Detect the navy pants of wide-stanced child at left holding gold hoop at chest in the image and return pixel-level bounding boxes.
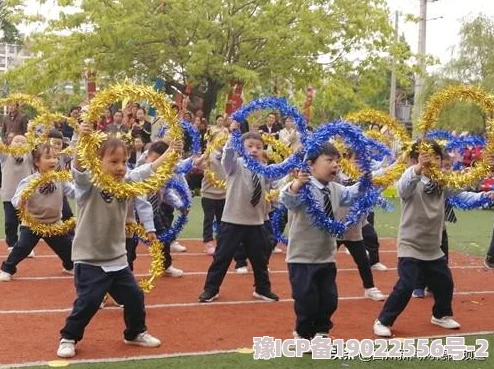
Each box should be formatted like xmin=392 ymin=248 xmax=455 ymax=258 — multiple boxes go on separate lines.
xmin=2 ymin=226 xmax=74 ymax=274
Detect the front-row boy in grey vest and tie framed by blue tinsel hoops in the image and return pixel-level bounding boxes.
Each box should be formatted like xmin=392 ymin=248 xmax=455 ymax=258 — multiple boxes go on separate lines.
xmin=281 ymin=142 xmax=359 ymax=339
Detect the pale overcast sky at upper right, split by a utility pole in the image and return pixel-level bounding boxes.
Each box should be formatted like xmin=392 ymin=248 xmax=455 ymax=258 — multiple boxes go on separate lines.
xmin=386 ymin=0 xmax=494 ymax=63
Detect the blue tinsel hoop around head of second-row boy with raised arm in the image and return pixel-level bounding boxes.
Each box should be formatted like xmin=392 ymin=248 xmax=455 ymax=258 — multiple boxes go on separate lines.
xmin=232 ymin=97 xmax=309 ymax=179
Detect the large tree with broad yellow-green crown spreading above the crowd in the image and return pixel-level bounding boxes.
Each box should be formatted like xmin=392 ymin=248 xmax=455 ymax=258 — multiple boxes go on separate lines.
xmin=3 ymin=0 xmax=398 ymax=118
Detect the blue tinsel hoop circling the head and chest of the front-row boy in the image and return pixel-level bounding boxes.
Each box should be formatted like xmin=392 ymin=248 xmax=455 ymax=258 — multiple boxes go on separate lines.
xmin=300 ymin=121 xmax=382 ymax=237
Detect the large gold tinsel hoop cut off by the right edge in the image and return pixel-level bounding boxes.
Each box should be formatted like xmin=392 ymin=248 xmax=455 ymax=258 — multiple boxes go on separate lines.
xmin=418 ymin=85 xmax=494 ymax=189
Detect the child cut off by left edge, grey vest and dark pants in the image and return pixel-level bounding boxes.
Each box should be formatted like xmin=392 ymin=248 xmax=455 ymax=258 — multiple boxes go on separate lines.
xmin=0 ymin=135 xmax=33 ymax=250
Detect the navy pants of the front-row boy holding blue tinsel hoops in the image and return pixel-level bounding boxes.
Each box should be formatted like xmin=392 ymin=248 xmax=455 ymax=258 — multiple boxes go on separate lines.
xmin=288 ymin=263 xmax=338 ymax=339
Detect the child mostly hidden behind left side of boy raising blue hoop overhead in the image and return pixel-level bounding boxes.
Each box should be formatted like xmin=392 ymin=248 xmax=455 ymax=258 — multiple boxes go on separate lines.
xmin=201 ymin=136 xmax=226 ymax=255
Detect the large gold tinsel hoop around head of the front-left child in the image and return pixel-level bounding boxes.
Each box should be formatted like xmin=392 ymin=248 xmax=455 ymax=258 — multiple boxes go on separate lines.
xmin=76 ymin=83 xmax=183 ymax=198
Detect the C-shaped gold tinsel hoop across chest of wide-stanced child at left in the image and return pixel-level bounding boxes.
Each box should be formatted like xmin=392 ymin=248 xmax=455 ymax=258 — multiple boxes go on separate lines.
xmin=19 ymin=170 xmax=75 ymax=237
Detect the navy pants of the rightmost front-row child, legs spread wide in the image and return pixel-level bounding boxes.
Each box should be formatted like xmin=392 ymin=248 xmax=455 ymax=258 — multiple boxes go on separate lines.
xmin=379 ymin=257 xmax=454 ymax=326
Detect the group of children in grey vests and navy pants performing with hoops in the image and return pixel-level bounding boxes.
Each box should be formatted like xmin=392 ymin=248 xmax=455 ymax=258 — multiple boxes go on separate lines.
xmin=0 ymin=109 xmax=494 ymax=357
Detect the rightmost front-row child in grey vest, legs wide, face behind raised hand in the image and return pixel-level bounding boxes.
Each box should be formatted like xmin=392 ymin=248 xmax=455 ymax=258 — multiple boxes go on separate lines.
xmin=374 ymin=141 xmax=494 ymax=337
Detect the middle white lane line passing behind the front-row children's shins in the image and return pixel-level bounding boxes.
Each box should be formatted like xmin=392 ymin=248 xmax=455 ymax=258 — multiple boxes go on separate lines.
xmin=0 ymin=290 xmax=494 ymax=315
